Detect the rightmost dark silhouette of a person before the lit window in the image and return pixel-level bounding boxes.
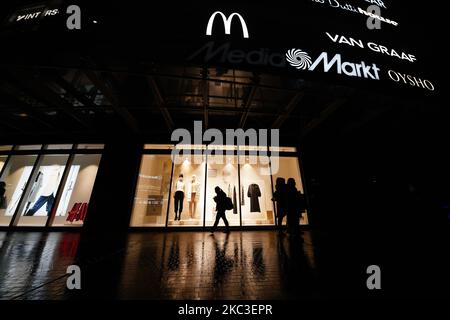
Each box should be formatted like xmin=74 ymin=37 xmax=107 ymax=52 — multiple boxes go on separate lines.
xmin=286 ymin=178 xmax=305 ymax=240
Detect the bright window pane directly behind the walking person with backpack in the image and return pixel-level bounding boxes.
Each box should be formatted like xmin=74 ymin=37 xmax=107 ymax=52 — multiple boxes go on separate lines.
xmin=205 ymin=152 xmax=242 ymax=227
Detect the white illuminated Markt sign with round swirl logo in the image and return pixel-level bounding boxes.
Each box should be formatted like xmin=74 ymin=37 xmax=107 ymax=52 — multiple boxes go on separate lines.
xmin=286 ymin=49 xmax=380 ymax=80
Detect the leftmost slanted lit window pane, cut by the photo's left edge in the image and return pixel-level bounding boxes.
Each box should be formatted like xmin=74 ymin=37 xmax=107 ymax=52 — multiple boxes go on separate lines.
xmin=0 ymin=155 xmax=37 ymax=226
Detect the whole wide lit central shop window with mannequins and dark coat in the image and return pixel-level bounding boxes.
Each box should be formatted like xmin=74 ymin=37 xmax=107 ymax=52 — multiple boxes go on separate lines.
xmin=131 ymin=145 xmax=308 ymax=227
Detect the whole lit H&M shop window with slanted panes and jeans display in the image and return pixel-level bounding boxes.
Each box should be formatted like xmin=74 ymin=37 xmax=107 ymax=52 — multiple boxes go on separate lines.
xmin=0 ymin=145 xmax=101 ymax=227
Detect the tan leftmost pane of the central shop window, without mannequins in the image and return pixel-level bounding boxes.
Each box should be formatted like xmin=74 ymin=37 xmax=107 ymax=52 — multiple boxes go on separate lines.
xmin=131 ymin=155 xmax=172 ymax=227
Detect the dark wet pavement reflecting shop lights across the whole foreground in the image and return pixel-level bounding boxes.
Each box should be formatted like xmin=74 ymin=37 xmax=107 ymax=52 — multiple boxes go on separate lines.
xmin=0 ymin=231 xmax=450 ymax=300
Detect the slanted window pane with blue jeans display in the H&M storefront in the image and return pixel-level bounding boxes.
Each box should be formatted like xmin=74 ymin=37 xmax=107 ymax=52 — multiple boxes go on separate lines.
xmin=17 ymin=155 xmax=69 ymax=226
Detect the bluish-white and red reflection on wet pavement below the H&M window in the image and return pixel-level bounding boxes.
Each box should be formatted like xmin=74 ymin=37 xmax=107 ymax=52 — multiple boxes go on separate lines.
xmin=0 ymin=232 xmax=80 ymax=300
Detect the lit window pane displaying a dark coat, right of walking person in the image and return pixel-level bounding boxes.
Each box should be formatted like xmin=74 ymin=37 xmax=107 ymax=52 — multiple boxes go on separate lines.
xmin=239 ymin=155 xmax=275 ymax=225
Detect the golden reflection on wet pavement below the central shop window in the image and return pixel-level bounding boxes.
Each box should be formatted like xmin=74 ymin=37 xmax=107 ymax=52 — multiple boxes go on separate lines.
xmin=118 ymin=232 xmax=315 ymax=299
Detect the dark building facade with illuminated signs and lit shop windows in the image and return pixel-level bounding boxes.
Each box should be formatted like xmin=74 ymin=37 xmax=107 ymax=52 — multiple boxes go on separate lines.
xmin=0 ymin=0 xmax=450 ymax=300
